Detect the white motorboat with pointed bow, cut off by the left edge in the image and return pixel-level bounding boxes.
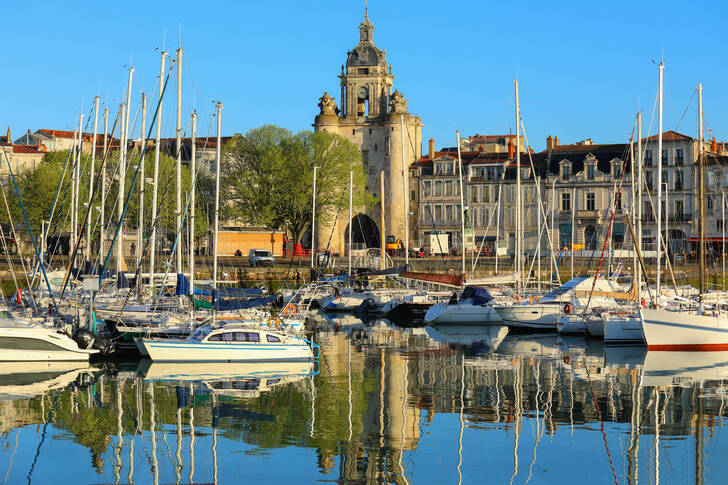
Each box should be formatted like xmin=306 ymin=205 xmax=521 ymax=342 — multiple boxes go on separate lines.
xmin=0 ymin=312 xmax=98 ymax=362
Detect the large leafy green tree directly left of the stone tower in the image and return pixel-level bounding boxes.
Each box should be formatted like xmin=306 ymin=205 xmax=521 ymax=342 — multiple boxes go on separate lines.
xmin=221 ymin=125 xmax=375 ymax=243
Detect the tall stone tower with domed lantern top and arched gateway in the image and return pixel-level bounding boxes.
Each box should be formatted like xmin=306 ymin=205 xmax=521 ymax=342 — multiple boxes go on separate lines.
xmin=313 ymin=13 xmax=422 ymax=252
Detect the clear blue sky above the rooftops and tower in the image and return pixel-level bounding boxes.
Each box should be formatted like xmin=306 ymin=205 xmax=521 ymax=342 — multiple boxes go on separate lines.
xmin=0 ymin=0 xmax=728 ymax=150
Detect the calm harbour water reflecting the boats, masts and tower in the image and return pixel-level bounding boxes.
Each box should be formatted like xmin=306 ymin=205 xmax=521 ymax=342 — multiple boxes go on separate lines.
xmin=0 ymin=317 xmax=728 ymax=484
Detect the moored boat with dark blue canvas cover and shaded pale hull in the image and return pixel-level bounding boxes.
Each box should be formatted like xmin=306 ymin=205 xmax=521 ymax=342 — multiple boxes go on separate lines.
xmin=425 ymin=286 xmax=503 ymax=325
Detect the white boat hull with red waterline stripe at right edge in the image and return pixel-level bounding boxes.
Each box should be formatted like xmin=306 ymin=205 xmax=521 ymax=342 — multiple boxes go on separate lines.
xmin=640 ymin=308 xmax=728 ymax=351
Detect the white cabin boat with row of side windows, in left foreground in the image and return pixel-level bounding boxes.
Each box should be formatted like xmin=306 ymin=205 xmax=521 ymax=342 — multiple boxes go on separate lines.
xmin=137 ymin=324 xmax=318 ymax=362
